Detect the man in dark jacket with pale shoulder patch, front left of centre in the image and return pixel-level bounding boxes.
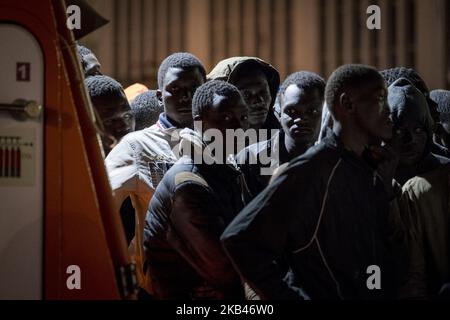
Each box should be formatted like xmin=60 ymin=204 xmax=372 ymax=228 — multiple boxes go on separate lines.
xmin=144 ymin=80 xmax=248 ymax=299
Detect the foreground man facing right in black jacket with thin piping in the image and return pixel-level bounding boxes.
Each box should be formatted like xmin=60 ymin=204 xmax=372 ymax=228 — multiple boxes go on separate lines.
xmin=222 ymin=65 xmax=395 ymax=299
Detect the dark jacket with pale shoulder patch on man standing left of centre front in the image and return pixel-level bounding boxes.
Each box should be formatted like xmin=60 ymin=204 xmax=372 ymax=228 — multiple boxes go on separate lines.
xmin=144 ymin=136 xmax=248 ymax=299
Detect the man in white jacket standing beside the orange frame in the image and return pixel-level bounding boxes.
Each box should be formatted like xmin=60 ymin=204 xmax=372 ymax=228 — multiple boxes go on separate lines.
xmin=105 ymin=53 xmax=206 ymax=293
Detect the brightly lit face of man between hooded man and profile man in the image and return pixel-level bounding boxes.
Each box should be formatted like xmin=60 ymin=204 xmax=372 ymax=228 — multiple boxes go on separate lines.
xmin=280 ymin=84 xmax=323 ymax=145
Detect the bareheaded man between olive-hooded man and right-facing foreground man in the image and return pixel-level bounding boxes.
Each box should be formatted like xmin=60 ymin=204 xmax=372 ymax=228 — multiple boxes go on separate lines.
xmin=236 ymin=71 xmax=325 ymax=197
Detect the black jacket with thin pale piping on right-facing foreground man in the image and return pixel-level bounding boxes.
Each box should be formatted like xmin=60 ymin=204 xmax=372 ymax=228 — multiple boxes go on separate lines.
xmin=222 ymin=134 xmax=393 ymax=299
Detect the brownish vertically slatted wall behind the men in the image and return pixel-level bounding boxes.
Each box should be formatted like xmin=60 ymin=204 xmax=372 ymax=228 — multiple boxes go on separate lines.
xmin=82 ymin=0 xmax=450 ymax=89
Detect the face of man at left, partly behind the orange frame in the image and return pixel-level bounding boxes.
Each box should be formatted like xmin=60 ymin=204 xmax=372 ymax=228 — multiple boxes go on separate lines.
xmin=93 ymin=93 xmax=135 ymax=141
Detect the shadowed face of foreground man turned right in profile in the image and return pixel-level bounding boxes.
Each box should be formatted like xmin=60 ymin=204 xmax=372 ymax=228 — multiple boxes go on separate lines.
xmin=350 ymin=79 xmax=393 ymax=142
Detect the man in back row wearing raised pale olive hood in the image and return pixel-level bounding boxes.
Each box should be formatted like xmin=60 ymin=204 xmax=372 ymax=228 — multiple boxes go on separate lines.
xmin=207 ymin=57 xmax=280 ymax=135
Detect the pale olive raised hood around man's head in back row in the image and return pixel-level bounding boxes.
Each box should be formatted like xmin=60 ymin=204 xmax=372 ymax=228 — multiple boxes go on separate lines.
xmin=207 ymin=57 xmax=280 ymax=107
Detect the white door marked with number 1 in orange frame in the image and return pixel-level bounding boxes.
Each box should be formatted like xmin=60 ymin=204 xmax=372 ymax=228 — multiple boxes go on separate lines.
xmin=0 ymin=23 xmax=44 ymax=299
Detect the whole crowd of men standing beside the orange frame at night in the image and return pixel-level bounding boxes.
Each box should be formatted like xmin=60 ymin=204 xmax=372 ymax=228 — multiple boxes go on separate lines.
xmin=78 ymin=46 xmax=450 ymax=299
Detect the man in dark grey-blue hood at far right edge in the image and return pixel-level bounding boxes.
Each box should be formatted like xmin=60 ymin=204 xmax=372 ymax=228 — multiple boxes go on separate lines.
xmin=389 ymin=86 xmax=450 ymax=299
